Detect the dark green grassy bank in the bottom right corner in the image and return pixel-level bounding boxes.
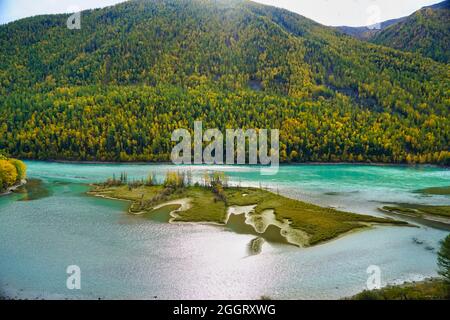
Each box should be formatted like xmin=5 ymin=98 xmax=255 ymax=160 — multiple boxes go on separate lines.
xmin=351 ymin=279 xmax=450 ymax=300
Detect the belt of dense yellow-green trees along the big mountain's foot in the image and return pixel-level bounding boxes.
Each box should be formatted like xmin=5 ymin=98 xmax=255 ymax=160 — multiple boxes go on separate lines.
xmin=0 ymin=86 xmax=450 ymax=163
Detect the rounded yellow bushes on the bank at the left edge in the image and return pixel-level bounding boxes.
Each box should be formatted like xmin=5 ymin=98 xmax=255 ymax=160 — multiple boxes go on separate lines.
xmin=0 ymin=154 xmax=26 ymax=193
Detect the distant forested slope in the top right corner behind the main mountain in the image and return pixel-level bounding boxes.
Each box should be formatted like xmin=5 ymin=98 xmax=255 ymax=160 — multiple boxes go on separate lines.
xmin=371 ymin=0 xmax=450 ymax=63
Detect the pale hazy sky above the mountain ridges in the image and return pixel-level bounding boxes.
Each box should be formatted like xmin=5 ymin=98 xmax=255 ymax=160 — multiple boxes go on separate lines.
xmin=0 ymin=0 xmax=442 ymax=26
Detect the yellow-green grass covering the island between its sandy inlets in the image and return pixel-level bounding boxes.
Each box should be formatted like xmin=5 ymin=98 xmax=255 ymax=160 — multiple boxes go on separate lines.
xmin=90 ymin=186 xmax=407 ymax=245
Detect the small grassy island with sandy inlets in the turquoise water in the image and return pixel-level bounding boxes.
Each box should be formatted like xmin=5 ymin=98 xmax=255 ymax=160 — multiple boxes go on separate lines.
xmin=89 ymin=172 xmax=408 ymax=248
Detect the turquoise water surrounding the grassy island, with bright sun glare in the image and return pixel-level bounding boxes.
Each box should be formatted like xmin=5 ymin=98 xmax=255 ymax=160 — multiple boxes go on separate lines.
xmin=0 ymin=161 xmax=450 ymax=299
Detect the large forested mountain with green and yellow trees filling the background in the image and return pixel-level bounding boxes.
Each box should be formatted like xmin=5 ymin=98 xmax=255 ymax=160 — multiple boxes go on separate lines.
xmin=0 ymin=0 xmax=450 ymax=163
